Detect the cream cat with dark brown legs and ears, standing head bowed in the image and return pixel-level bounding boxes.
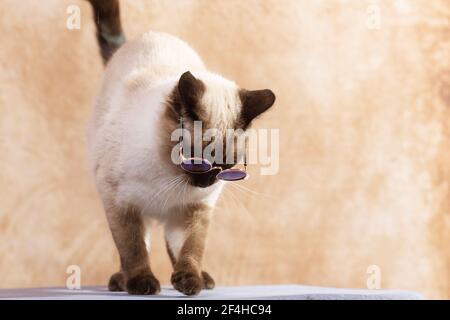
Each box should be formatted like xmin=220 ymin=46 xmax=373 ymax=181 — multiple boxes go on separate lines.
xmin=88 ymin=1 xmax=275 ymax=295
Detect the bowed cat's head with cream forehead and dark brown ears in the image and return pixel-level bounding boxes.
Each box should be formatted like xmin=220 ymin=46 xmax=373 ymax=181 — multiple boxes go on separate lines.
xmin=172 ymin=72 xmax=275 ymax=188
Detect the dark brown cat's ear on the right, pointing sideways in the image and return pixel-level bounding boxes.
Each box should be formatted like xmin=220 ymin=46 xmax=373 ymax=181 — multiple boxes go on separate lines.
xmin=239 ymin=89 xmax=275 ymax=127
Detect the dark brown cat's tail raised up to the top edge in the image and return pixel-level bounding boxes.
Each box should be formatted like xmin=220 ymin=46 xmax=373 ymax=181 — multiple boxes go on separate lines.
xmin=88 ymin=0 xmax=125 ymax=64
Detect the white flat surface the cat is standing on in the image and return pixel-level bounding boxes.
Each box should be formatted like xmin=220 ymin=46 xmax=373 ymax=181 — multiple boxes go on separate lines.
xmin=0 ymin=285 xmax=424 ymax=300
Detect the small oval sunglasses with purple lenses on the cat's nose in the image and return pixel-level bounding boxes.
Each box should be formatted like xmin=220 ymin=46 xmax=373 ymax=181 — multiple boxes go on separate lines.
xmin=180 ymin=117 xmax=249 ymax=181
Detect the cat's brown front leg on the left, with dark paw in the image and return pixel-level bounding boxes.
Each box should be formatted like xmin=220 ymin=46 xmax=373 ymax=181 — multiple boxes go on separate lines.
xmin=106 ymin=206 xmax=161 ymax=294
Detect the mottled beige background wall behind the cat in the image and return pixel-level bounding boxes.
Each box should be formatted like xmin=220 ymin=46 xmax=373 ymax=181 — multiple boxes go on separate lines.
xmin=0 ymin=0 xmax=450 ymax=298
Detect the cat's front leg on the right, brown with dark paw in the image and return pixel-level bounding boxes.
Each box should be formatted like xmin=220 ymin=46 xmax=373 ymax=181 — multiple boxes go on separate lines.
xmin=166 ymin=204 xmax=214 ymax=295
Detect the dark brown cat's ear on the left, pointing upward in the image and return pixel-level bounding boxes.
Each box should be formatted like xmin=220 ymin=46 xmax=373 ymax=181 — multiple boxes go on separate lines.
xmin=178 ymin=71 xmax=205 ymax=120
